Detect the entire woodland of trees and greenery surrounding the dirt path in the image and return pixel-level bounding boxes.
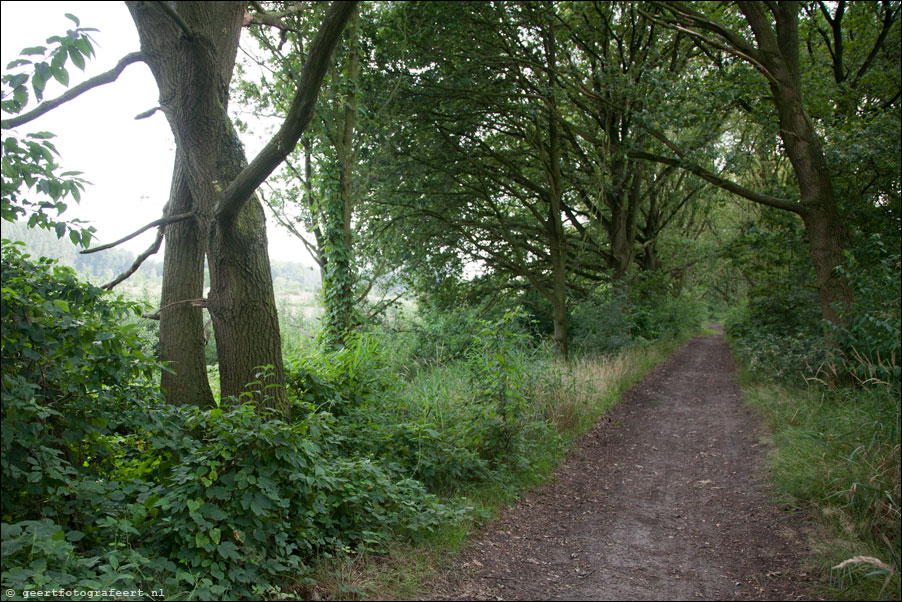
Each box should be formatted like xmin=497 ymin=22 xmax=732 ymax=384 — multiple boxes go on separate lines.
xmin=2 ymin=1 xmax=902 ymax=599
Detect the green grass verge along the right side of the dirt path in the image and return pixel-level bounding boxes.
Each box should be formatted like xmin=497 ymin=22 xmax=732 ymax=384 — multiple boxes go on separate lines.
xmin=741 ymin=373 xmax=902 ymax=600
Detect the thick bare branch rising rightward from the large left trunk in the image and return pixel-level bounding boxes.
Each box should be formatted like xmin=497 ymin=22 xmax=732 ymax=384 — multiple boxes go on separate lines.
xmin=214 ymin=0 xmax=357 ymax=223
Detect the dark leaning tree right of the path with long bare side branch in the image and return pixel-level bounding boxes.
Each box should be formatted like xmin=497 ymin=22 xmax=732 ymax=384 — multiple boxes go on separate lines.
xmin=633 ymin=2 xmax=899 ymax=324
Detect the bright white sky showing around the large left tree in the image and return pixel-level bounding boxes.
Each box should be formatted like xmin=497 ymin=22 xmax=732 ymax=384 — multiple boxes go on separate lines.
xmin=0 ymin=1 xmax=312 ymax=264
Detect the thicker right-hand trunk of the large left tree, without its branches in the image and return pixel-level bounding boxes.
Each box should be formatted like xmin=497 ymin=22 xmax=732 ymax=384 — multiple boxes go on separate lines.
xmin=128 ymin=2 xmax=287 ymax=411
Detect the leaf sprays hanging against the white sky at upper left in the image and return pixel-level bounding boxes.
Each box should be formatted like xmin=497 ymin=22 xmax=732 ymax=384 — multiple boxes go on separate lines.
xmin=0 ymin=14 xmax=96 ymax=247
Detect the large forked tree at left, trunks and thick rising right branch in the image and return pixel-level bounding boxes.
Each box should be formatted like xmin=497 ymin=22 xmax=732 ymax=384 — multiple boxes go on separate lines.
xmin=127 ymin=1 xmax=355 ymax=412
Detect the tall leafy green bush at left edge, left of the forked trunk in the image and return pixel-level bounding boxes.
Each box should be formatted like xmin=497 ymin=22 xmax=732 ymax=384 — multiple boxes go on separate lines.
xmin=2 ymin=241 xmax=158 ymax=515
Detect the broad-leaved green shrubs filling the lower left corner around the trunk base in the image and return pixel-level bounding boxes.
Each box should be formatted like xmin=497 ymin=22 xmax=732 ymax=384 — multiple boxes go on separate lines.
xmin=2 ymin=246 xmax=462 ymax=599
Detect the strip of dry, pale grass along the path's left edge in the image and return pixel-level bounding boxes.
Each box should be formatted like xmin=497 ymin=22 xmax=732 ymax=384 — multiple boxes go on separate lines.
xmin=295 ymin=336 xmax=688 ymax=600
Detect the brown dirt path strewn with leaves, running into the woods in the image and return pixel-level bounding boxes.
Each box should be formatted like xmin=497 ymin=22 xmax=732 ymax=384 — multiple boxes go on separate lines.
xmin=427 ymin=336 xmax=810 ymax=600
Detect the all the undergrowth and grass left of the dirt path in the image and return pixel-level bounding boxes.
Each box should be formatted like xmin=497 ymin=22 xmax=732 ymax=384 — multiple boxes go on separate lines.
xmin=0 ymin=244 xmax=708 ymax=600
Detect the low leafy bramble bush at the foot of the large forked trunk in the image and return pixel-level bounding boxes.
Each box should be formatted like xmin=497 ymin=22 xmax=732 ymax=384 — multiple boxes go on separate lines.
xmin=150 ymin=405 xmax=459 ymax=599
